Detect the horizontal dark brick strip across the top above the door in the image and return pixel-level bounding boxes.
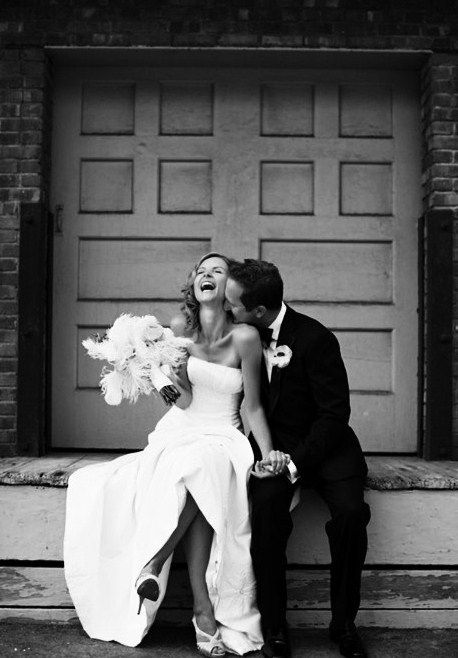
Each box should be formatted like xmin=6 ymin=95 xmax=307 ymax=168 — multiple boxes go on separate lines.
xmin=0 ymin=0 xmax=458 ymax=52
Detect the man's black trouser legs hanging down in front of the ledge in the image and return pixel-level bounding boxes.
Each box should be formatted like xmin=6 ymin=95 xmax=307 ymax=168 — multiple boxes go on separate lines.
xmin=250 ymin=476 xmax=370 ymax=633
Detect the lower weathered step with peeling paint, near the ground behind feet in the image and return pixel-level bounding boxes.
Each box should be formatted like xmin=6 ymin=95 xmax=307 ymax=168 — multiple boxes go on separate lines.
xmin=0 ymin=564 xmax=458 ymax=628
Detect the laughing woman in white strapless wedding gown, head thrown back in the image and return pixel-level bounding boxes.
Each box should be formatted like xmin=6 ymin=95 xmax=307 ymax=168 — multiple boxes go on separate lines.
xmin=64 ymin=253 xmax=286 ymax=656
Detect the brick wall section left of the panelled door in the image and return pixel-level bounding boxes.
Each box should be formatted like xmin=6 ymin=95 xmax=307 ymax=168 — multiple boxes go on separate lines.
xmin=0 ymin=47 xmax=51 ymax=455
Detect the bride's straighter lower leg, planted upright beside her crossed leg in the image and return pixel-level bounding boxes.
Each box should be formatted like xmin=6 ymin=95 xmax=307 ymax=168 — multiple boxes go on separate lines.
xmin=183 ymin=510 xmax=216 ymax=635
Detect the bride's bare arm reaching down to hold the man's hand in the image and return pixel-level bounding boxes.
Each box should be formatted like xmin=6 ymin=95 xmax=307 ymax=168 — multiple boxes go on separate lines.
xmin=235 ymin=325 xmax=273 ymax=459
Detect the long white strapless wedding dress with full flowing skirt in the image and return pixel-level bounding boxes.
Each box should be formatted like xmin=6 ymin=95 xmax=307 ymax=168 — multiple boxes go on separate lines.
xmin=64 ymin=356 xmax=262 ymax=654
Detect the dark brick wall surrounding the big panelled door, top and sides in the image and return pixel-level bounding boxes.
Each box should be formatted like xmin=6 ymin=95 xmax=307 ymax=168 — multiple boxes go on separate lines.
xmin=0 ymin=0 xmax=458 ymax=458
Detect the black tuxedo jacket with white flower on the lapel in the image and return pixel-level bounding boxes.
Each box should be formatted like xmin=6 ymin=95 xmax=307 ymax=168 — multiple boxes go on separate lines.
xmin=253 ymin=306 xmax=367 ymax=483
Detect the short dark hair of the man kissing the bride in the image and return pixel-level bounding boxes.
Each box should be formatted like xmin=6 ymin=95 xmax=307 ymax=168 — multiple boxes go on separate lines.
xmin=229 ymin=258 xmax=283 ymax=311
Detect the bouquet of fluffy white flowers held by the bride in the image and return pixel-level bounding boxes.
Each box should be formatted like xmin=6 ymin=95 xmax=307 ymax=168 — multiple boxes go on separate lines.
xmin=82 ymin=313 xmax=192 ymax=405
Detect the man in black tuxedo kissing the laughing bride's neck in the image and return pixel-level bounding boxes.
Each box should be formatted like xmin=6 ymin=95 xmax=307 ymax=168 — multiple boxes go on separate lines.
xmin=226 ymin=259 xmax=370 ymax=658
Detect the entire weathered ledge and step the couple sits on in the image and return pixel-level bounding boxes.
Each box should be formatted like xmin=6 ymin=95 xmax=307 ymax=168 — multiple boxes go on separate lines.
xmin=0 ymin=454 xmax=458 ymax=628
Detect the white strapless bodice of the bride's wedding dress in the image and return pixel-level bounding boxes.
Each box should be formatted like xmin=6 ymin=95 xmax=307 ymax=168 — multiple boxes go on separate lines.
xmin=185 ymin=356 xmax=243 ymax=428
